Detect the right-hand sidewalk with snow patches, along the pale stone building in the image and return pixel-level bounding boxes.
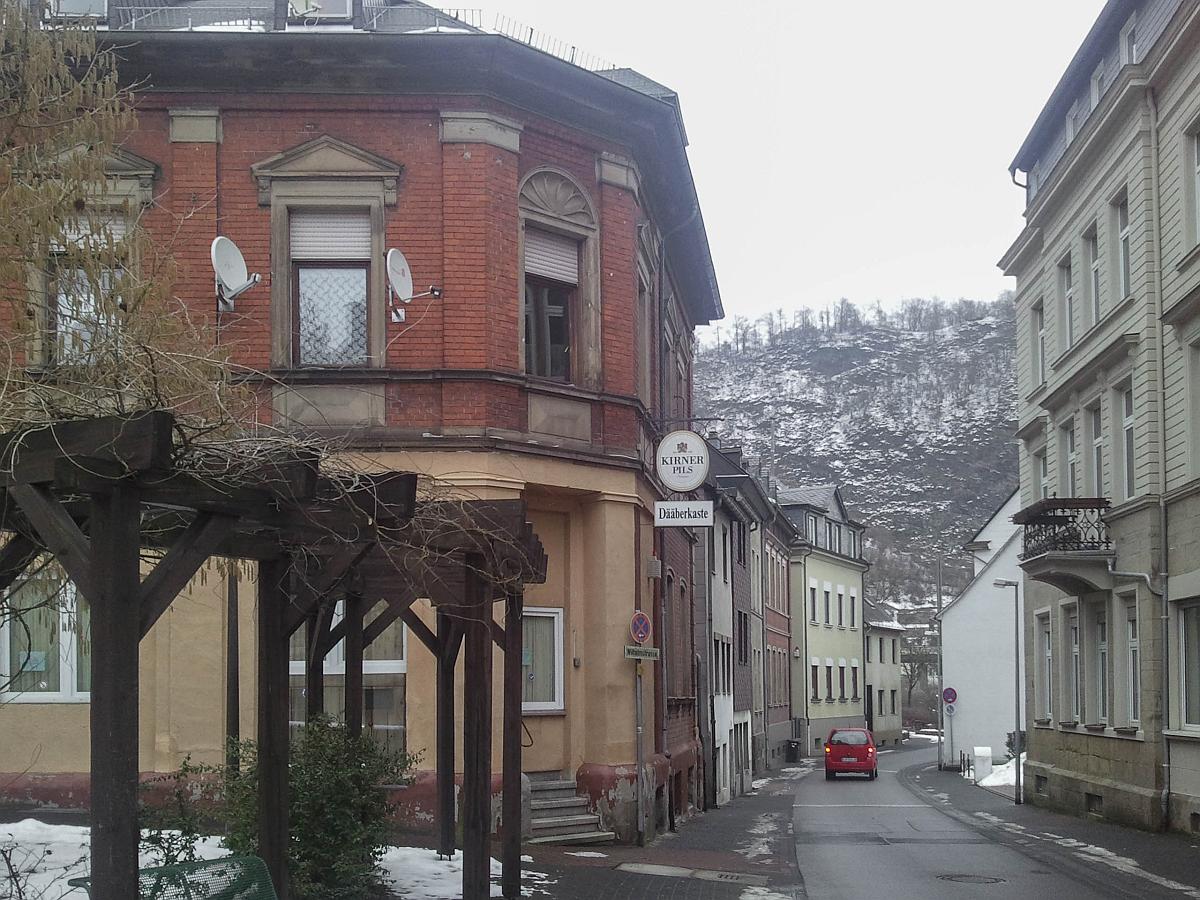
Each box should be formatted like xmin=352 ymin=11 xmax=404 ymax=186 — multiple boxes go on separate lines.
xmin=899 ymin=766 xmax=1200 ymax=898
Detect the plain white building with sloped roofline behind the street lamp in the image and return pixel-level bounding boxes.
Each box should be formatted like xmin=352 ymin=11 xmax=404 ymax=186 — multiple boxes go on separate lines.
xmin=938 ymin=491 xmax=1025 ymax=763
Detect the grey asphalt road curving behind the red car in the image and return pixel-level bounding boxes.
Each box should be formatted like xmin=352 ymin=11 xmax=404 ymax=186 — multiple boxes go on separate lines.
xmin=793 ymin=748 xmax=1195 ymax=900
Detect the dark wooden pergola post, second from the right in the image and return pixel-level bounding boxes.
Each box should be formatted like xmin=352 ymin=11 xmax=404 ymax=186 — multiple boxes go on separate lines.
xmin=462 ymin=564 xmax=492 ymax=900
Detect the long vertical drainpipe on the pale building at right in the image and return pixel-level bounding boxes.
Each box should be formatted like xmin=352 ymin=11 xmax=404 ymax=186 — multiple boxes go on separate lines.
xmin=1146 ymin=88 xmax=1171 ymax=832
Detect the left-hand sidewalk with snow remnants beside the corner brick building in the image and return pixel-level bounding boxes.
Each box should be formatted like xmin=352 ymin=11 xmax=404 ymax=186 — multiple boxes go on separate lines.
xmin=526 ymin=764 xmax=811 ymax=900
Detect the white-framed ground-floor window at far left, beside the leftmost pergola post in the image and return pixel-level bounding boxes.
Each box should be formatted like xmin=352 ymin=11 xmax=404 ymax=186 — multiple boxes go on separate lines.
xmin=0 ymin=563 xmax=91 ymax=703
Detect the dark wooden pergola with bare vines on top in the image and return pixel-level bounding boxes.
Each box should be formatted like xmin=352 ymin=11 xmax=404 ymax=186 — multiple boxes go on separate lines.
xmin=0 ymin=412 xmax=546 ymax=900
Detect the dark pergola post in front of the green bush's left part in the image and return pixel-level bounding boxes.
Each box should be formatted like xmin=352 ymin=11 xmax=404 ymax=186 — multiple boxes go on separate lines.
xmin=258 ymin=558 xmax=289 ymax=900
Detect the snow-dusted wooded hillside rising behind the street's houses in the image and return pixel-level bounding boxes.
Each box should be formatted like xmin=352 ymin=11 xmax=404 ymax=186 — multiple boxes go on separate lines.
xmin=695 ymin=301 xmax=1016 ymax=600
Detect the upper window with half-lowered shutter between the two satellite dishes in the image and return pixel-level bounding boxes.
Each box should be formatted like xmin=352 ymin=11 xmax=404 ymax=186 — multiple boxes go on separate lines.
xmin=289 ymin=210 xmax=371 ymax=366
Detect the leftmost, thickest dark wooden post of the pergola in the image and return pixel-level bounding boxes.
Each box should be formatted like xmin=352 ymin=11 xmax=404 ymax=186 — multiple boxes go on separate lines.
xmin=86 ymin=485 xmax=142 ymax=898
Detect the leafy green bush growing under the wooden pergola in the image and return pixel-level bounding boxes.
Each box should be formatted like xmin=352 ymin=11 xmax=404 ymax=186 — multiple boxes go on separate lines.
xmin=224 ymin=718 xmax=416 ymax=900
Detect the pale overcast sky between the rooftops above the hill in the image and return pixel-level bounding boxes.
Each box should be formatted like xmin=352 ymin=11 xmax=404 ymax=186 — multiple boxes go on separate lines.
xmin=486 ymin=0 xmax=1104 ymax=320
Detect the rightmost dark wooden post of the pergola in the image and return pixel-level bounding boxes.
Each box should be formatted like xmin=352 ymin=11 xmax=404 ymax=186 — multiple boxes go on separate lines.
xmin=500 ymin=587 xmax=523 ymax=900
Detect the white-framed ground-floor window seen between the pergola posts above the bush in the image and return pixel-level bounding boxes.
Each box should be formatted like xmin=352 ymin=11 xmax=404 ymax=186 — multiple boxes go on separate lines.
xmin=288 ymin=602 xmax=408 ymax=751
